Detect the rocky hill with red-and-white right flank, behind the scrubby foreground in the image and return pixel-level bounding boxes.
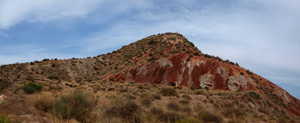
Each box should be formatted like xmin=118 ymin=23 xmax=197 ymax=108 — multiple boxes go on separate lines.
xmin=0 ymin=33 xmax=300 ymax=122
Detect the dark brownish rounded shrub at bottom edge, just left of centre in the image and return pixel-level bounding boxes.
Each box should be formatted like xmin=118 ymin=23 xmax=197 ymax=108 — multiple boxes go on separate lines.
xmin=104 ymin=101 xmax=142 ymax=123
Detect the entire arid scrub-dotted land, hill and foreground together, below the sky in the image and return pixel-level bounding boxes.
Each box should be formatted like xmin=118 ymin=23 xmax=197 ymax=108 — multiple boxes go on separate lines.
xmin=0 ymin=33 xmax=300 ymax=123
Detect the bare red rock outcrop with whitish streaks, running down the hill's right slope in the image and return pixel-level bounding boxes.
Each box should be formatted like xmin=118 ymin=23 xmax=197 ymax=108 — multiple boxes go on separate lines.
xmin=110 ymin=53 xmax=300 ymax=116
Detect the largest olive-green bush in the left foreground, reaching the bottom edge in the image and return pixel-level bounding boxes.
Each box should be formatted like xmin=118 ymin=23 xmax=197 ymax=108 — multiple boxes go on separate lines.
xmin=50 ymin=91 xmax=96 ymax=122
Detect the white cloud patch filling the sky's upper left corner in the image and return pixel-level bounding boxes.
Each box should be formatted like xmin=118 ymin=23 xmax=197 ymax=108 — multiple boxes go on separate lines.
xmin=0 ymin=0 xmax=102 ymax=29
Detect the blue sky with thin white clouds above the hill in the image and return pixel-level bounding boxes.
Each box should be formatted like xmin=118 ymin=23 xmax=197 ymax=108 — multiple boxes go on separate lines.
xmin=0 ymin=0 xmax=300 ymax=99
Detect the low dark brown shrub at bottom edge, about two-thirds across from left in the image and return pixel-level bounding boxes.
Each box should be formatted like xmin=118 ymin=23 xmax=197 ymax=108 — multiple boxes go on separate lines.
xmin=198 ymin=110 xmax=222 ymax=123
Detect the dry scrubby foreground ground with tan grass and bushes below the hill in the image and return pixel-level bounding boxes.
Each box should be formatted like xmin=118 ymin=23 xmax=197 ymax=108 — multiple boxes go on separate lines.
xmin=1 ymin=81 xmax=299 ymax=123
